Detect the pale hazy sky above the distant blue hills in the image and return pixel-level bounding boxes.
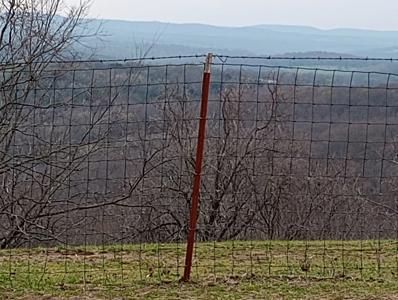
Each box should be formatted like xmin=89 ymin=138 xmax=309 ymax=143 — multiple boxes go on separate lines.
xmin=65 ymin=0 xmax=398 ymax=30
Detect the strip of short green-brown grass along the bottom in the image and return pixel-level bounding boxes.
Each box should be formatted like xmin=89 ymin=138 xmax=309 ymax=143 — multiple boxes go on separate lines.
xmin=0 ymin=240 xmax=398 ymax=299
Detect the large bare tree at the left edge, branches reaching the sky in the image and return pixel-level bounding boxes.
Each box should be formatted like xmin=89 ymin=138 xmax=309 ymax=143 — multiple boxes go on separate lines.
xmin=0 ymin=0 xmax=169 ymax=248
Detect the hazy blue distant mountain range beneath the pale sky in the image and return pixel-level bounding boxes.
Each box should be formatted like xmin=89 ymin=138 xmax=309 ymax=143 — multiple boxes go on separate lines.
xmin=81 ymin=20 xmax=398 ymax=58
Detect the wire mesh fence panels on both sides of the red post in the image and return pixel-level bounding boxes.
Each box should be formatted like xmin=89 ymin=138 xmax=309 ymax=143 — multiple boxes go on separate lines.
xmin=0 ymin=55 xmax=398 ymax=288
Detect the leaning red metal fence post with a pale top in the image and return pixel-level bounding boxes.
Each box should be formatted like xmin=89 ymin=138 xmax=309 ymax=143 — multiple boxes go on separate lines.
xmin=182 ymin=53 xmax=213 ymax=281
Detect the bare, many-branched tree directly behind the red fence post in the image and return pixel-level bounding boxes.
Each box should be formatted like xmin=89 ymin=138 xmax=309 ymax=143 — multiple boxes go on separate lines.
xmin=132 ymin=77 xmax=294 ymax=241
